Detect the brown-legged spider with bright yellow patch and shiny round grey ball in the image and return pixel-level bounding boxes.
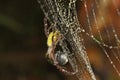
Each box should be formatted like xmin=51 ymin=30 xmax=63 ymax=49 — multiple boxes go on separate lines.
xmin=44 ymin=18 xmax=78 ymax=75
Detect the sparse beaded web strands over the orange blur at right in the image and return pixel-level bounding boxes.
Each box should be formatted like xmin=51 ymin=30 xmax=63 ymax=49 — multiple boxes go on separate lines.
xmin=81 ymin=0 xmax=120 ymax=77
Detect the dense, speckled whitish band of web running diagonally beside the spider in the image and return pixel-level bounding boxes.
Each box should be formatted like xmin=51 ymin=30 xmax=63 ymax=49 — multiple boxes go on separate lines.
xmin=38 ymin=0 xmax=95 ymax=80
